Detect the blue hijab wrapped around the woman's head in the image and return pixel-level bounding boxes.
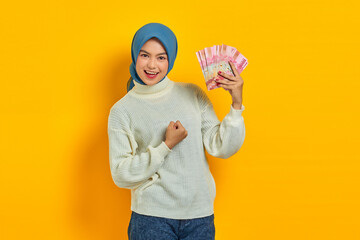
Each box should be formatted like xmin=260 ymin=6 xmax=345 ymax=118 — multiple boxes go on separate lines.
xmin=127 ymin=23 xmax=178 ymax=92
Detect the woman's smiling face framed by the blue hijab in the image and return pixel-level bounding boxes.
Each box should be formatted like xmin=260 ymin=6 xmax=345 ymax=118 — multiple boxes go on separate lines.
xmin=136 ymin=38 xmax=169 ymax=86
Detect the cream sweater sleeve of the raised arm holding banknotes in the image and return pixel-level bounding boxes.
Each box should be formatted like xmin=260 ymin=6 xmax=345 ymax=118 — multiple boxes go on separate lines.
xmin=198 ymin=86 xmax=245 ymax=159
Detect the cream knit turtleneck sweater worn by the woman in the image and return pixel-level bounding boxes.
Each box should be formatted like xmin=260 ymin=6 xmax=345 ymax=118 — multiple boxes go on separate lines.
xmin=108 ymin=76 xmax=245 ymax=219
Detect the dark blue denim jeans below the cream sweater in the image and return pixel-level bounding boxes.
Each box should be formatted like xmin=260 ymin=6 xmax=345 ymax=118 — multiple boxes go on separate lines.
xmin=128 ymin=211 xmax=215 ymax=240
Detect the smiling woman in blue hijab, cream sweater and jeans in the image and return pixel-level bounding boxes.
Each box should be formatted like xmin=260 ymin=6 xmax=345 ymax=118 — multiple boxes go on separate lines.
xmin=108 ymin=23 xmax=245 ymax=240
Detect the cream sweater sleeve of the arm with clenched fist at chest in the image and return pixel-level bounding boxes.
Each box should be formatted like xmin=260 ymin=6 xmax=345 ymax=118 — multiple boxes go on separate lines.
xmin=108 ymin=107 xmax=172 ymax=189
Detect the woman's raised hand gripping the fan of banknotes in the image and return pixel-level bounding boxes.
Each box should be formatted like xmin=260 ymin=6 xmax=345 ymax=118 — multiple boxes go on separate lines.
xmin=216 ymin=61 xmax=244 ymax=107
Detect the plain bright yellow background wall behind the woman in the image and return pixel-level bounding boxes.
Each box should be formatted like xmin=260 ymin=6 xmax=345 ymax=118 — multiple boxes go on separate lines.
xmin=0 ymin=0 xmax=360 ymax=240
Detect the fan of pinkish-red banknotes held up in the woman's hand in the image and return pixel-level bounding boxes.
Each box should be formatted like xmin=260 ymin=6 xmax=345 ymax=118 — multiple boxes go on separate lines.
xmin=196 ymin=44 xmax=248 ymax=90
